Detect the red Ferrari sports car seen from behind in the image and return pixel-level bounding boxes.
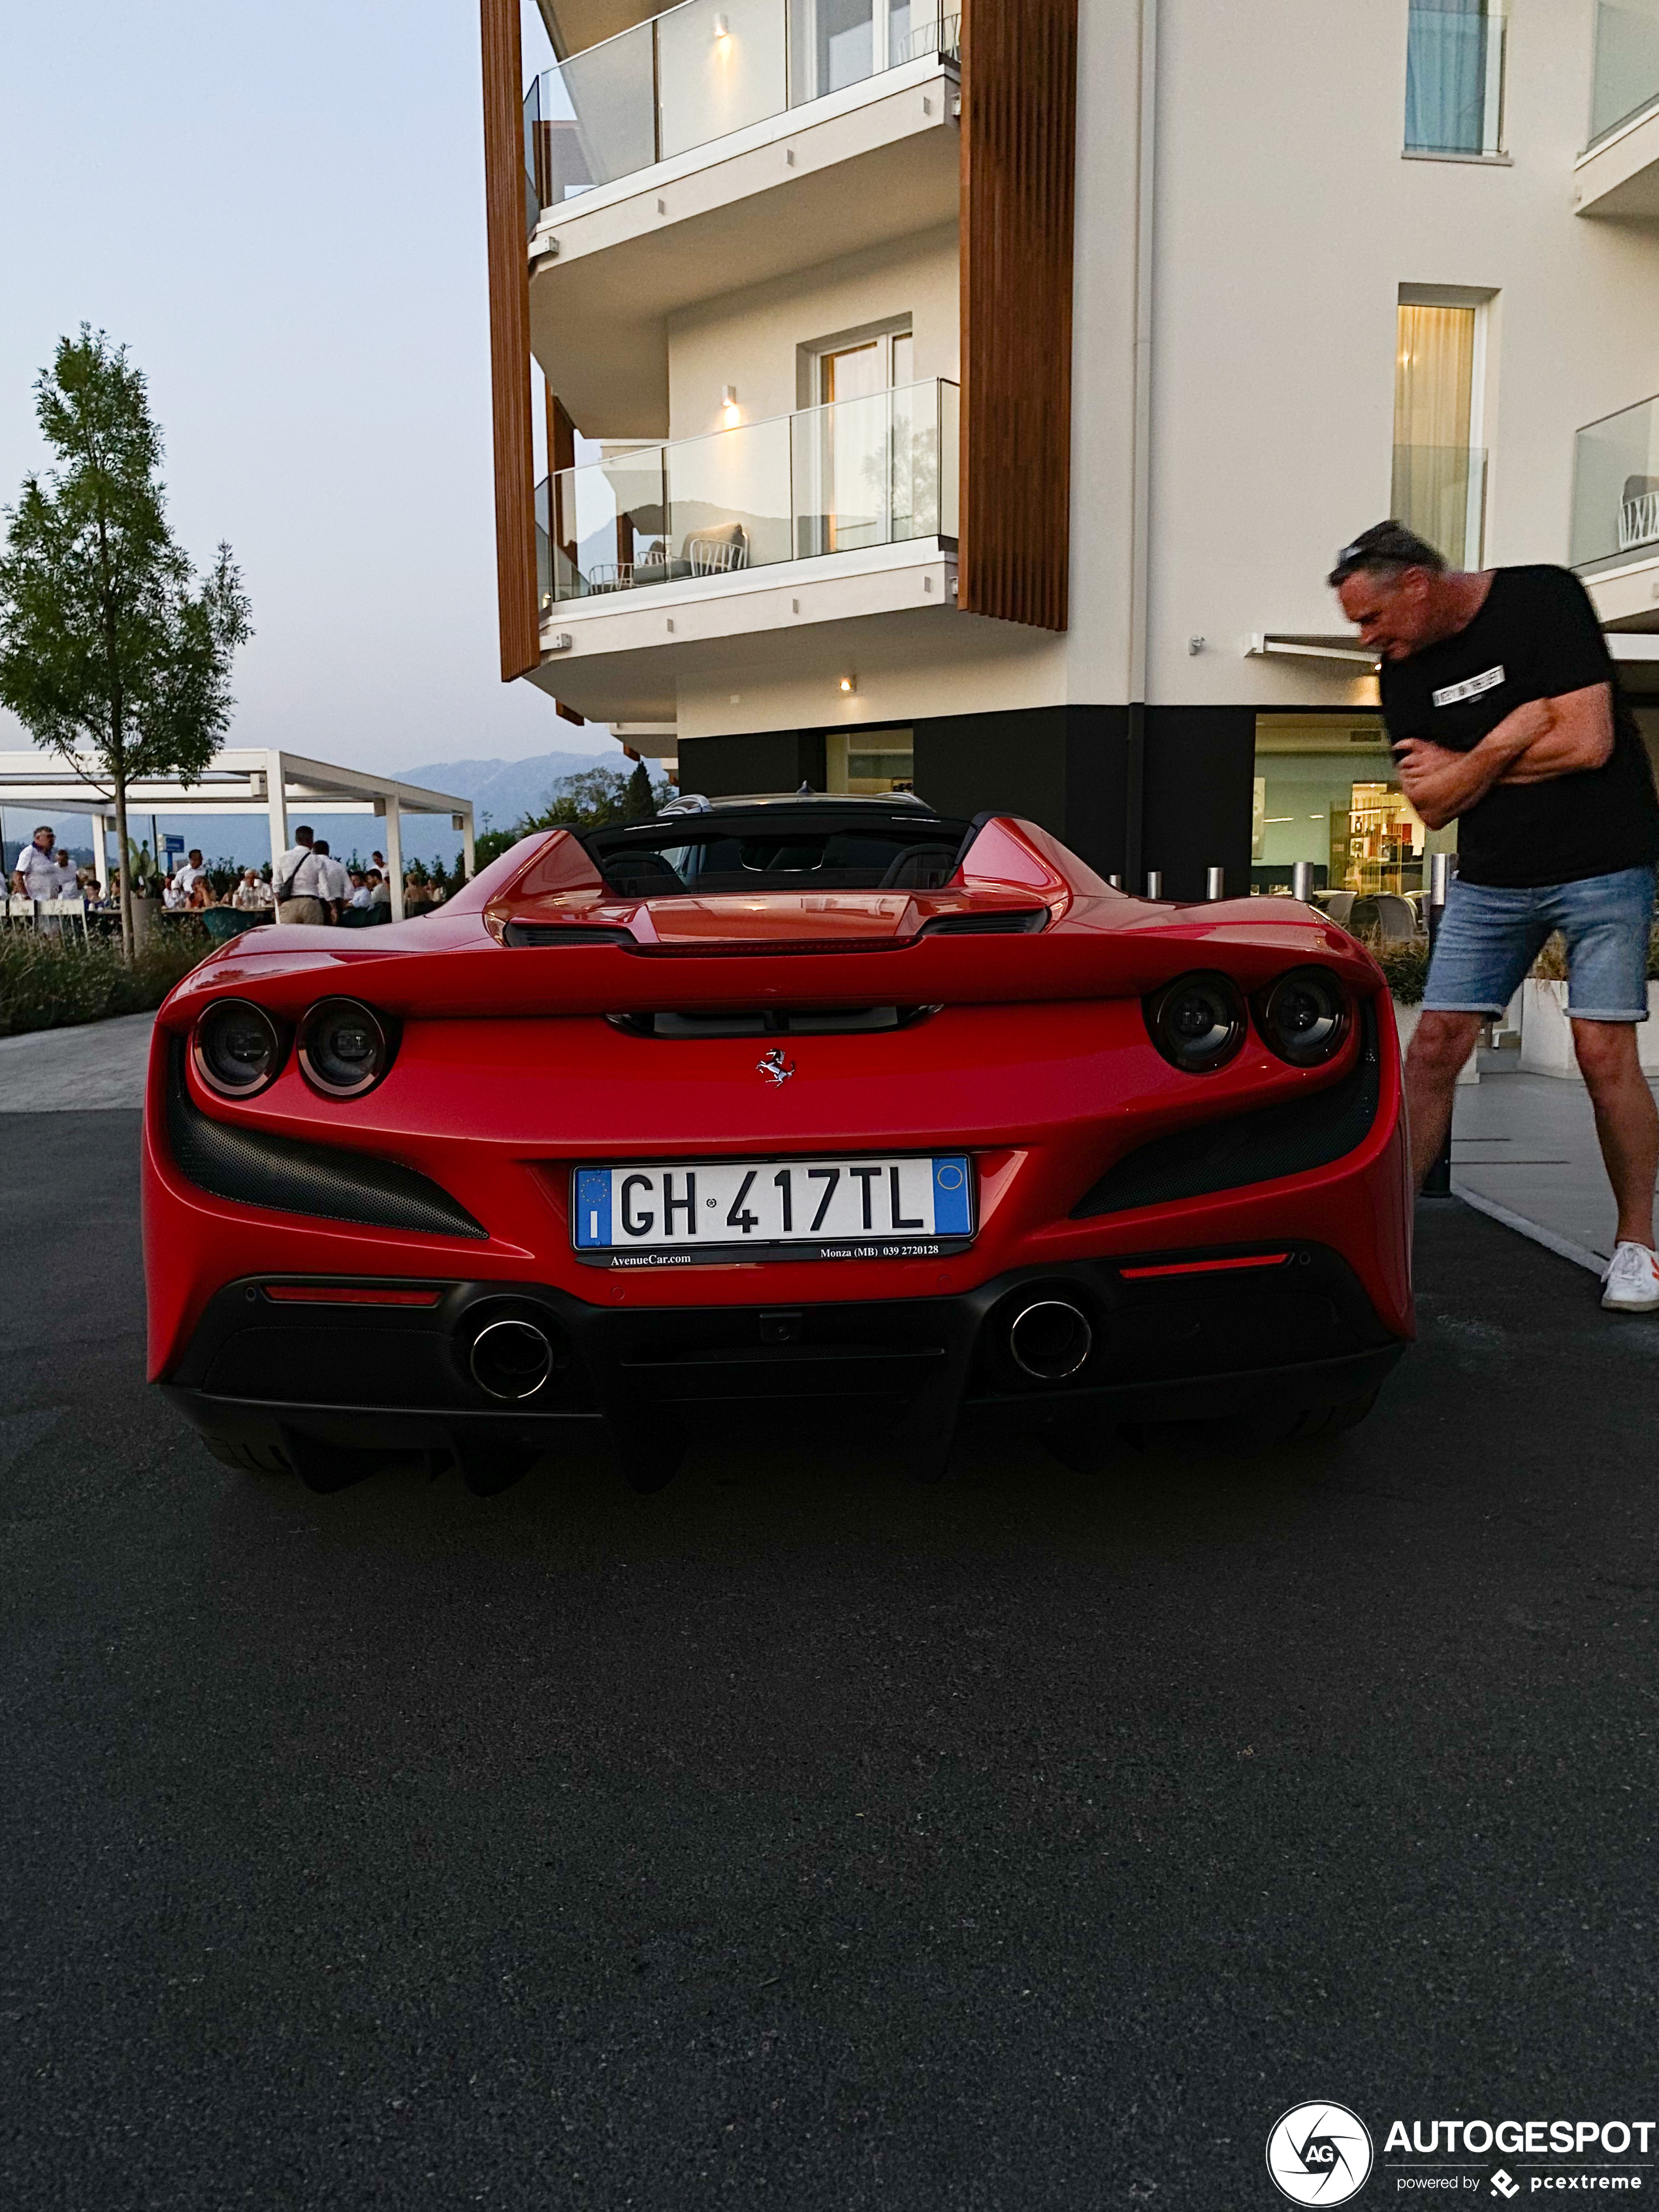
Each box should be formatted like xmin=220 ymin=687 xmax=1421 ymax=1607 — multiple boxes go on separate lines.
xmin=144 ymin=796 xmax=1411 ymax=1488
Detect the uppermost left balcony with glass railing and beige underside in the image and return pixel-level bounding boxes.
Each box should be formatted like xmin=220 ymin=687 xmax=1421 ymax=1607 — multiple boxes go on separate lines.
xmin=524 ymin=0 xmax=962 ymax=438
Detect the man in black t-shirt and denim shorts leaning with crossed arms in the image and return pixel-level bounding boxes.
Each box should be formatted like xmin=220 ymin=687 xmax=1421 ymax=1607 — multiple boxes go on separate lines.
xmin=1329 ymin=522 xmax=1659 ymax=1311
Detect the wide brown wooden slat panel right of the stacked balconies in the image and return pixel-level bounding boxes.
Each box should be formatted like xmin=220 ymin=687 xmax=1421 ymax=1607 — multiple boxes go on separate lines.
xmin=958 ymin=0 xmax=1077 ymax=630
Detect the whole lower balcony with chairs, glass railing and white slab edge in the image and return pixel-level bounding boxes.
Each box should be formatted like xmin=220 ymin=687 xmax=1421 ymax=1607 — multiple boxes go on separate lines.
xmin=536 ymin=378 xmax=960 ymax=719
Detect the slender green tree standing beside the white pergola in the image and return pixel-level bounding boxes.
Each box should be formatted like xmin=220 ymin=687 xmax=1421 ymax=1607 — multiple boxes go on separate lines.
xmin=0 ymin=323 xmax=252 ymax=958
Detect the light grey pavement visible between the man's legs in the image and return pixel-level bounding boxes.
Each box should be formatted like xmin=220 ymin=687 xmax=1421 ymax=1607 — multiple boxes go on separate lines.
xmin=1451 ymin=1053 xmax=1654 ymax=1274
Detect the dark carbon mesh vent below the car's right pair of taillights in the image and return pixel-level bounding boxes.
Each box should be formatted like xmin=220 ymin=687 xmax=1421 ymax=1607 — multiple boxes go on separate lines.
xmin=1071 ymin=1006 xmax=1383 ymax=1221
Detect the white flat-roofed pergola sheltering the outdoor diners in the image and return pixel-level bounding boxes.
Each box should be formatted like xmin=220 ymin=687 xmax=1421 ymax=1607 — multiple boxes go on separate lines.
xmin=0 ymin=745 xmax=474 ymax=920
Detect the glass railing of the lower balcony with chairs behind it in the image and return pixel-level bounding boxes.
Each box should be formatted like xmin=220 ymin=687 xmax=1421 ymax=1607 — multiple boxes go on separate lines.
xmin=536 ymin=378 xmax=960 ymax=615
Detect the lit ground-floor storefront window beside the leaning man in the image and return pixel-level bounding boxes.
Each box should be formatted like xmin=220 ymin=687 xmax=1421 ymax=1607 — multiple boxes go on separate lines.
xmin=1249 ymin=714 xmax=1429 ymax=893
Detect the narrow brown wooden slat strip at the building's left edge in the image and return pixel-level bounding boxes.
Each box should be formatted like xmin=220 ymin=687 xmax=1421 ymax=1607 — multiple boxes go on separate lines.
xmin=480 ymin=0 xmax=542 ymax=684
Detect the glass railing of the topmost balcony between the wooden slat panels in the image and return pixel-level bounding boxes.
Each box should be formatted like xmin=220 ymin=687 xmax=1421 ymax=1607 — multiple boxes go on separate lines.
xmin=524 ymin=0 xmax=960 ymax=230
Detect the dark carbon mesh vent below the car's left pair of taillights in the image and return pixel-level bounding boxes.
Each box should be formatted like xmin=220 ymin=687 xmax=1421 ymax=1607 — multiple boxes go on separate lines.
xmin=168 ymin=1042 xmax=489 ymax=1236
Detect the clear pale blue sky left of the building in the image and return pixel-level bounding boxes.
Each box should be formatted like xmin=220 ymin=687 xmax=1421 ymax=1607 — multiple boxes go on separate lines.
xmin=0 ymin=0 xmax=604 ymax=767
